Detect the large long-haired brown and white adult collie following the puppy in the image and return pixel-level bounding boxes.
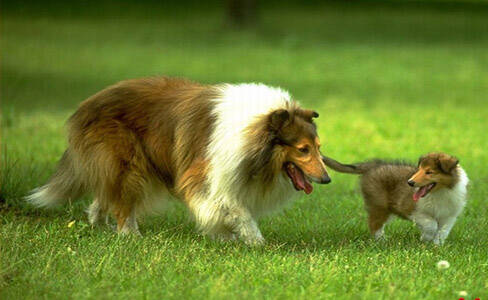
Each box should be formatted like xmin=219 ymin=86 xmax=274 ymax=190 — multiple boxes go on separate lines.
xmin=27 ymin=78 xmax=330 ymax=244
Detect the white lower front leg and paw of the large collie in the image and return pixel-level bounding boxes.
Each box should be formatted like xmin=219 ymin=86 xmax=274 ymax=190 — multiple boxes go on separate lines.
xmin=224 ymin=207 xmax=264 ymax=245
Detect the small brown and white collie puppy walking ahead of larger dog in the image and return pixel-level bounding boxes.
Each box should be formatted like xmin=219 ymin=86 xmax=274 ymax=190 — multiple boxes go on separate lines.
xmin=324 ymin=153 xmax=469 ymax=244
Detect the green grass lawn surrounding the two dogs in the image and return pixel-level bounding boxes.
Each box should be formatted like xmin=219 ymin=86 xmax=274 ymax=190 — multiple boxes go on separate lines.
xmin=0 ymin=2 xmax=488 ymax=299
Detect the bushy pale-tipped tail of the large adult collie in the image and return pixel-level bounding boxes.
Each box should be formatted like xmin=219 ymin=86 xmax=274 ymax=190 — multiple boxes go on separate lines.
xmin=25 ymin=149 xmax=84 ymax=207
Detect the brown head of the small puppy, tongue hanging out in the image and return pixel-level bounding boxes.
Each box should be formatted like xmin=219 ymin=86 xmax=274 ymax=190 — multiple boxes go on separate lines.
xmin=408 ymin=153 xmax=459 ymax=201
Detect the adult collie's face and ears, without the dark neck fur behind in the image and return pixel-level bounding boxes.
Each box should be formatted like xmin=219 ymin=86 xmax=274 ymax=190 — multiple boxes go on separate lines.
xmin=268 ymin=108 xmax=331 ymax=194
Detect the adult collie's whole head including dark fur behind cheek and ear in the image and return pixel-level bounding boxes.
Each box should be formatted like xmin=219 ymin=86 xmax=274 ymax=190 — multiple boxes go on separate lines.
xmin=242 ymin=106 xmax=331 ymax=194
